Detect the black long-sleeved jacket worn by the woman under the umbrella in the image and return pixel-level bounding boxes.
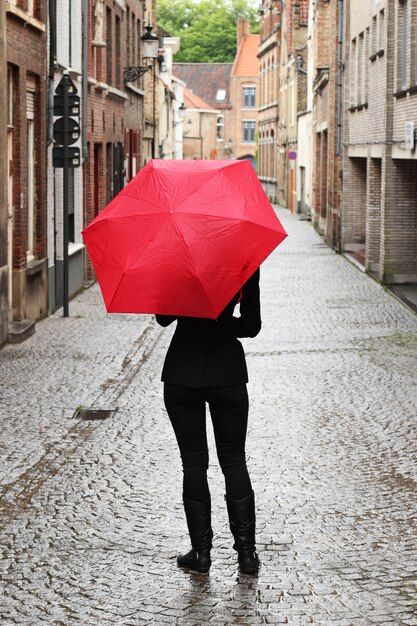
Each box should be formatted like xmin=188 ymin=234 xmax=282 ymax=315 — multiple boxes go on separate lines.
xmin=156 ymin=269 xmax=261 ymax=387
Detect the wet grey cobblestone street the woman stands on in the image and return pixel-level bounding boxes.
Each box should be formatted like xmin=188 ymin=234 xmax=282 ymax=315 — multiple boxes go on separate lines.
xmin=0 ymin=209 xmax=417 ymax=626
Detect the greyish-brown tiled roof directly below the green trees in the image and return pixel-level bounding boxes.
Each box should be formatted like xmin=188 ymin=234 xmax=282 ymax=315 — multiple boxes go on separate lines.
xmin=172 ymin=63 xmax=232 ymax=109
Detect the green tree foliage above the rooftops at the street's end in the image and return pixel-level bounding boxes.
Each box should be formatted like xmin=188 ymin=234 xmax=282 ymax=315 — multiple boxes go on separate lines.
xmin=157 ymin=0 xmax=259 ymax=63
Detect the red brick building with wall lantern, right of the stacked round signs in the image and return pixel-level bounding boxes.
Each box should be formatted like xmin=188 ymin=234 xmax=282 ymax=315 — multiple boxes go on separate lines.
xmin=84 ymin=0 xmax=147 ymax=278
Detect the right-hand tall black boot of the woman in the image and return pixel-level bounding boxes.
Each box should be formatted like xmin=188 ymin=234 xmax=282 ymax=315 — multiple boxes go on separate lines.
xmin=226 ymin=491 xmax=259 ymax=574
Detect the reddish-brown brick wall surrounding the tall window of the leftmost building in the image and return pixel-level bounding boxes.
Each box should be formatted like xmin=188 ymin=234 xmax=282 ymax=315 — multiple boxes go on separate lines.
xmin=6 ymin=0 xmax=47 ymax=320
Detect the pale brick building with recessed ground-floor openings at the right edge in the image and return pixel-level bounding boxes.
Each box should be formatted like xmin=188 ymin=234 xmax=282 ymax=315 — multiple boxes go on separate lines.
xmin=342 ymin=0 xmax=417 ymax=289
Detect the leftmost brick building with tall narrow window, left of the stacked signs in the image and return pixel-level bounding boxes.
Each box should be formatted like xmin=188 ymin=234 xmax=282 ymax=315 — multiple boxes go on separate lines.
xmin=2 ymin=0 xmax=48 ymax=340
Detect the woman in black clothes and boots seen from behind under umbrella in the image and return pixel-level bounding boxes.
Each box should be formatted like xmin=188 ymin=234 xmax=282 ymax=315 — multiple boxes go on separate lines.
xmin=156 ymin=269 xmax=261 ymax=574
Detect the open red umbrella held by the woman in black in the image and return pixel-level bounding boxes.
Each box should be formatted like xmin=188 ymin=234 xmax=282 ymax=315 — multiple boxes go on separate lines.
xmin=83 ymin=160 xmax=287 ymax=318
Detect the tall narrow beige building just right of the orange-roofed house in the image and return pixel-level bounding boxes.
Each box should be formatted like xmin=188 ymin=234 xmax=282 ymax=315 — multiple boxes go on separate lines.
xmin=258 ymin=0 xmax=281 ymax=202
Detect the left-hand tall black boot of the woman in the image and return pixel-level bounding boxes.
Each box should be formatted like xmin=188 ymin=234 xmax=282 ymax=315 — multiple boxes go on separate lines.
xmin=177 ymin=498 xmax=213 ymax=573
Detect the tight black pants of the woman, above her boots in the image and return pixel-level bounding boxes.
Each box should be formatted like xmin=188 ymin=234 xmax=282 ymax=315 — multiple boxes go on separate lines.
xmin=164 ymin=383 xmax=252 ymax=502
